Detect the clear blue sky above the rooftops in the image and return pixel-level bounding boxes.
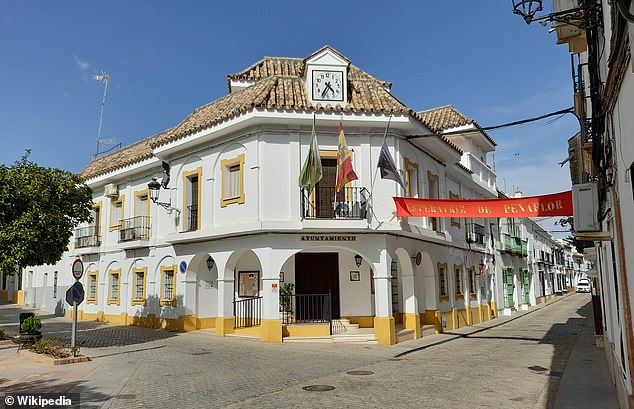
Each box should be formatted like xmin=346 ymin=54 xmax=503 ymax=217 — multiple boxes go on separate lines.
xmin=0 ymin=0 xmax=578 ymax=202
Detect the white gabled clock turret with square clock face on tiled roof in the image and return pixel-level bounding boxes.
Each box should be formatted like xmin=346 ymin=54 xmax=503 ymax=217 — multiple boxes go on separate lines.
xmin=304 ymin=46 xmax=350 ymax=107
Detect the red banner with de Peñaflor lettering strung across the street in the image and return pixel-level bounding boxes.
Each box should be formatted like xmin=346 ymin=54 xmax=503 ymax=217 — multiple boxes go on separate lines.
xmin=394 ymin=191 xmax=572 ymax=218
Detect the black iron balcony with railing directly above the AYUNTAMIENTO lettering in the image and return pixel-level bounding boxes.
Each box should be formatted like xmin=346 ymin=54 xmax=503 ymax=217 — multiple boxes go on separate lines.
xmin=301 ymin=186 xmax=370 ymax=220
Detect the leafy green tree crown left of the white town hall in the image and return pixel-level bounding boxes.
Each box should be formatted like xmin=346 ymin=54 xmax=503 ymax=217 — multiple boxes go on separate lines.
xmin=0 ymin=150 xmax=92 ymax=272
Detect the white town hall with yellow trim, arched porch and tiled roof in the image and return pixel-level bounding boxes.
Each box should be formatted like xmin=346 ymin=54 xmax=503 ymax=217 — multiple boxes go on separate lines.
xmin=18 ymin=46 xmax=508 ymax=344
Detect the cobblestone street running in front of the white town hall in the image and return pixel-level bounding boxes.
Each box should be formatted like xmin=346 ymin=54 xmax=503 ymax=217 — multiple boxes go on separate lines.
xmin=0 ymin=294 xmax=615 ymax=408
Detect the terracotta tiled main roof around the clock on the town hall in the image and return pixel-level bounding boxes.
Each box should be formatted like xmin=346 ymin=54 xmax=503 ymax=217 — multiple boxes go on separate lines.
xmin=81 ymin=46 xmax=460 ymax=179
